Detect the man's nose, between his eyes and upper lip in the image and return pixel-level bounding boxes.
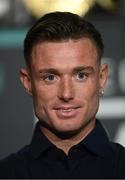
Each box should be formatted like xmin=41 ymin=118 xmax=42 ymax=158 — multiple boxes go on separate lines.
xmin=58 ymin=78 xmax=75 ymax=102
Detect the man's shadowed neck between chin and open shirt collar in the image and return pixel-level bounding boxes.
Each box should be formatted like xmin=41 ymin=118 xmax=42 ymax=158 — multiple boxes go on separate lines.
xmin=41 ymin=120 xmax=95 ymax=155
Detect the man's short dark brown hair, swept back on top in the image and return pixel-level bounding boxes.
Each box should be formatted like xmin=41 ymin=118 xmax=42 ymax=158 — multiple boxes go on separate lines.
xmin=24 ymin=12 xmax=104 ymax=66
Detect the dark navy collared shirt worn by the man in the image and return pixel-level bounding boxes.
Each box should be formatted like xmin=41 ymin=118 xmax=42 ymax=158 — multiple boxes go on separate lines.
xmin=0 ymin=120 xmax=125 ymax=179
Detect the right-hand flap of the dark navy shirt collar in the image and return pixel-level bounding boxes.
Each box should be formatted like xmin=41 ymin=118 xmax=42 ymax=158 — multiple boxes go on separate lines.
xmin=81 ymin=120 xmax=113 ymax=157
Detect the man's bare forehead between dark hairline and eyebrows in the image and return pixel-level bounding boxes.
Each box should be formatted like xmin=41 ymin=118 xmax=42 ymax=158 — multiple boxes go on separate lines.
xmin=31 ymin=38 xmax=98 ymax=70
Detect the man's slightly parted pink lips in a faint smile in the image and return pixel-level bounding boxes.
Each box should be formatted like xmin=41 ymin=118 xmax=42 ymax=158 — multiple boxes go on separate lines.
xmin=55 ymin=106 xmax=79 ymax=119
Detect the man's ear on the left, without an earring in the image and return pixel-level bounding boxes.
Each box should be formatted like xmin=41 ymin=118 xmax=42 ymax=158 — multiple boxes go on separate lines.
xmin=20 ymin=68 xmax=32 ymax=95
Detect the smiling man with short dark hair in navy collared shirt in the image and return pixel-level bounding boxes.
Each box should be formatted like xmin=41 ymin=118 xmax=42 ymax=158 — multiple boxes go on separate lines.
xmin=0 ymin=12 xmax=125 ymax=179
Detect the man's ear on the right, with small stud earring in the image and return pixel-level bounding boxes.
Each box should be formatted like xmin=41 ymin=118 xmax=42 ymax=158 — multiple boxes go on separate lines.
xmin=99 ymin=64 xmax=108 ymax=94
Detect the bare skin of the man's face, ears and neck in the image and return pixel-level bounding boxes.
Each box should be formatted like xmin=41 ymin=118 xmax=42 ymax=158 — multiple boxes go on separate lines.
xmin=21 ymin=38 xmax=108 ymax=154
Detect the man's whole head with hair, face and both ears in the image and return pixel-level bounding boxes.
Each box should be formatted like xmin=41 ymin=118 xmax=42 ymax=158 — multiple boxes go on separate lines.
xmin=21 ymin=12 xmax=107 ymax=139
